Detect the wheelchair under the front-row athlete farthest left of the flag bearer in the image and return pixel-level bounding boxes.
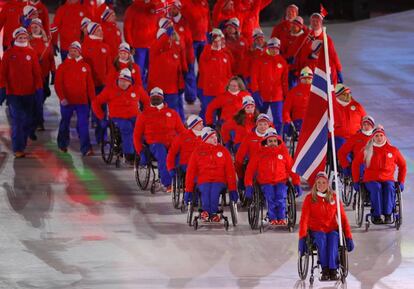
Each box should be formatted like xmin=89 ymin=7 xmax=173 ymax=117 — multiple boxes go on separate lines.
xmin=187 ymin=189 xmax=238 ymax=231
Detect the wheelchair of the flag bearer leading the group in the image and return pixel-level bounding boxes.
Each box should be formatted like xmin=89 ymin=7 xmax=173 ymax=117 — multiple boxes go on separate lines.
xmin=298 ymin=232 xmax=349 ymax=285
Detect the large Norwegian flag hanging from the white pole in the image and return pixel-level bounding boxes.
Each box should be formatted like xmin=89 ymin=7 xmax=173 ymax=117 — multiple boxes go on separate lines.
xmin=292 ymin=45 xmax=329 ymax=183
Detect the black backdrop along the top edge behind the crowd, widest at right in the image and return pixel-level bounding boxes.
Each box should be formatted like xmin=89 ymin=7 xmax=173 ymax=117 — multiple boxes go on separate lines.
xmin=43 ymin=0 xmax=414 ymax=22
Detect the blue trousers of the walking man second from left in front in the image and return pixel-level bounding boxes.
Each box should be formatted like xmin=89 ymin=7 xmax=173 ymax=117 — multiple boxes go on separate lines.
xmin=57 ymin=104 xmax=91 ymax=154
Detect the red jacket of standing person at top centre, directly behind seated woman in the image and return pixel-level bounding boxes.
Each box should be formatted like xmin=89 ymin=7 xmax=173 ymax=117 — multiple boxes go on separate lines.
xmin=198 ymin=45 xmax=233 ymax=96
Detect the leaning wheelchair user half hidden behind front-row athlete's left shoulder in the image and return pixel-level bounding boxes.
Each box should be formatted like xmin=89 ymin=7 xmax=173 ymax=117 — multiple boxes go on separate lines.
xmin=167 ymin=114 xmax=204 ymax=210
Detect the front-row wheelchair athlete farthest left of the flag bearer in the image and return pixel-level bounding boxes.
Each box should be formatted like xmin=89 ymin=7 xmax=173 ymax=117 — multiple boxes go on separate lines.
xmin=184 ymin=127 xmax=238 ymax=229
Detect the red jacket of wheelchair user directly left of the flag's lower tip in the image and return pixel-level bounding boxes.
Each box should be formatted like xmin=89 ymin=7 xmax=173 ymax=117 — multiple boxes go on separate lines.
xmin=244 ymin=142 xmax=300 ymax=186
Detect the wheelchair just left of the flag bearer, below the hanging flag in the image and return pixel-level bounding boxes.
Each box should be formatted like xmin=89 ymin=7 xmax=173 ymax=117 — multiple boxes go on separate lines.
xmin=247 ymin=181 xmax=296 ymax=233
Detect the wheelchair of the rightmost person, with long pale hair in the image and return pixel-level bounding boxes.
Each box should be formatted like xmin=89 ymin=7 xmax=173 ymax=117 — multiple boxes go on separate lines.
xmin=355 ymin=182 xmax=403 ymax=232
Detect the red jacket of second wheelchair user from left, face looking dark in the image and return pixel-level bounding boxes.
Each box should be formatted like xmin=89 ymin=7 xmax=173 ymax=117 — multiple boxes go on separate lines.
xmin=134 ymin=104 xmax=185 ymax=152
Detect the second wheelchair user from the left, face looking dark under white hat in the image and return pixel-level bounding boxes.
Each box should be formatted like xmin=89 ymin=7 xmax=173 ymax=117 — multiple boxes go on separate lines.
xmin=134 ymin=87 xmax=185 ymax=193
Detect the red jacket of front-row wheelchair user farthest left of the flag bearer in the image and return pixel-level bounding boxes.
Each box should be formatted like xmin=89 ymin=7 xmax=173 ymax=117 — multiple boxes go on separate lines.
xmin=185 ymin=143 xmax=236 ymax=192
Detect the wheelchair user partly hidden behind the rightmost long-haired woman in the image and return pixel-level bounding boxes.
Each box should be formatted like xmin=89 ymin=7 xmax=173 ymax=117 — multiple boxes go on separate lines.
xmin=338 ymin=115 xmax=375 ymax=206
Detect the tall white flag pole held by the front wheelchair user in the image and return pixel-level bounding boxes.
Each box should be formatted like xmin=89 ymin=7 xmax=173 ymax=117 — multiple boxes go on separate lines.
xmin=323 ymin=27 xmax=344 ymax=246
